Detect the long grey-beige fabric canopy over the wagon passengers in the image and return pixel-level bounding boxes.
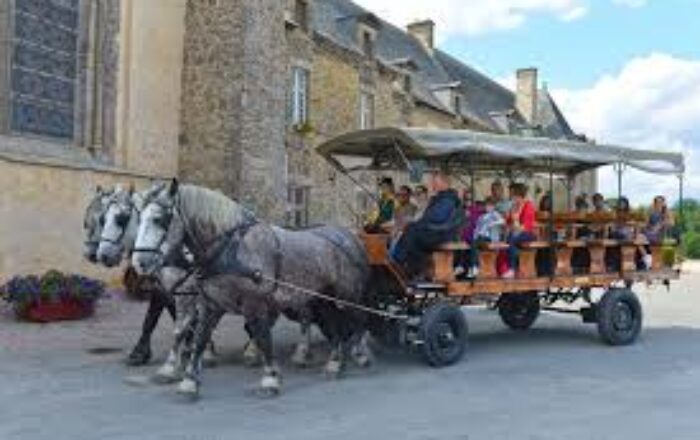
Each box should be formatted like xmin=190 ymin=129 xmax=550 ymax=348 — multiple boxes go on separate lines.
xmin=318 ymin=128 xmax=685 ymax=176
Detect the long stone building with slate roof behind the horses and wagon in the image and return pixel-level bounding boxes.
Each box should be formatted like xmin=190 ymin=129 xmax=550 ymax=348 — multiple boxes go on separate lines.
xmin=0 ymin=0 xmax=591 ymax=278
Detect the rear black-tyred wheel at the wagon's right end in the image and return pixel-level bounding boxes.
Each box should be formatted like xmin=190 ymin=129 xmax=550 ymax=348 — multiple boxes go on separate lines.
xmin=597 ymin=288 xmax=642 ymax=345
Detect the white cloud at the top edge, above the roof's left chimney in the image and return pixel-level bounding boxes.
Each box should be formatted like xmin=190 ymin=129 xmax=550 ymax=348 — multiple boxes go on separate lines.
xmin=355 ymin=0 xmax=588 ymax=39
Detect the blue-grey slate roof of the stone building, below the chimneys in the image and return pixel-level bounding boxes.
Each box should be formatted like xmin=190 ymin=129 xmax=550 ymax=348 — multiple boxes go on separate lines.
xmin=313 ymin=0 xmax=576 ymax=139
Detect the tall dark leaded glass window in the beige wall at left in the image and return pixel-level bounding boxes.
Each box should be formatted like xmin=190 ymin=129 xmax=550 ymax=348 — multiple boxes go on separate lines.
xmin=10 ymin=0 xmax=79 ymax=140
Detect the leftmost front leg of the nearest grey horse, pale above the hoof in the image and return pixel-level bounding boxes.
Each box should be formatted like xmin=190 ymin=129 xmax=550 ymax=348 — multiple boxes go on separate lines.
xmin=177 ymin=304 xmax=224 ymax=399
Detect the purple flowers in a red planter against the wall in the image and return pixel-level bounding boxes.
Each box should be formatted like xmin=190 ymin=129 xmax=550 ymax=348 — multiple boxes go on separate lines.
xmin=0 ymin=271 xmax=105 ymax=322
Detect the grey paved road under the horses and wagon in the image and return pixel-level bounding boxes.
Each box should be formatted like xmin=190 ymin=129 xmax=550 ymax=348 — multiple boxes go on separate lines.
xmin=0 ymin=266 xmax=700 ymax=440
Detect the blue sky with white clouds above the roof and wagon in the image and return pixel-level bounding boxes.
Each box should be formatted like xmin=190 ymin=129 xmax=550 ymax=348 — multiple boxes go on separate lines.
xmin=355 ymin=0 xmax=700 ymax=203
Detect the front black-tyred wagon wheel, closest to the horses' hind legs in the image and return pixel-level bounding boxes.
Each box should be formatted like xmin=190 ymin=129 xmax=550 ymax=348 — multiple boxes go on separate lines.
xmin=418 ymin=302 xmax=469 ymax=367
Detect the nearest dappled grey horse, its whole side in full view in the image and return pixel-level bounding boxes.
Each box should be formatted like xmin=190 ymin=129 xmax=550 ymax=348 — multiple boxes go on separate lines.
xmin=132 ymin=180 xmax=370 ymax=398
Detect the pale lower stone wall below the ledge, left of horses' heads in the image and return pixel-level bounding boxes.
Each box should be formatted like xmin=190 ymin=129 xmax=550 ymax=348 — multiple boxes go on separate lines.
xmin=0 ymin=149 xmax=149 ymax=284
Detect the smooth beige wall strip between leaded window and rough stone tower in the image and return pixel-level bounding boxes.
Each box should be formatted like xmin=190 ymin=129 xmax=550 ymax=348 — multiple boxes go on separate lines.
xmin=115 ymin=0 xmax=185 ymax=176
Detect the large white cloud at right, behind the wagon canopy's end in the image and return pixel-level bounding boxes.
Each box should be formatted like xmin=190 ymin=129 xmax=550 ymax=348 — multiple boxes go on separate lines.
xmin=552 ymin=53 xmax=700 ymax=203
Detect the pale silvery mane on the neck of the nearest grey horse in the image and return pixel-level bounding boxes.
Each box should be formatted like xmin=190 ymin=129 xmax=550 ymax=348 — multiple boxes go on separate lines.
xmin=179 ymin=185 xmax=252 ymax=239
